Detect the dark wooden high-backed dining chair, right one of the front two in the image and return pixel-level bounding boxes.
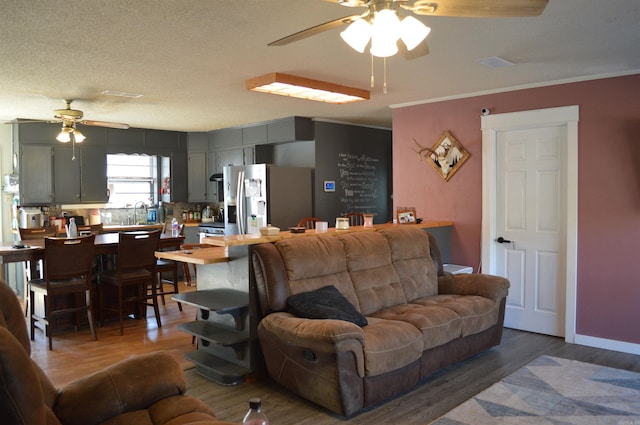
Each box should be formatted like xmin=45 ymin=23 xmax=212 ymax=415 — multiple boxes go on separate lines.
xmin=99 ymin=230 xmax=162 ymax=335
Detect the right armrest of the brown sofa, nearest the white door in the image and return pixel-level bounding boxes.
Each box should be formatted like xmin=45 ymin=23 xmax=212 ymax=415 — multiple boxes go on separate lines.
xmin=438 ymin=273 xmax=510 ymax=301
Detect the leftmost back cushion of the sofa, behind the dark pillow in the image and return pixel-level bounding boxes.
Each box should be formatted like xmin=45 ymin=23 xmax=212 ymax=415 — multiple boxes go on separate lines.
xmin=276 ymin=236 xmax=361 ymax=311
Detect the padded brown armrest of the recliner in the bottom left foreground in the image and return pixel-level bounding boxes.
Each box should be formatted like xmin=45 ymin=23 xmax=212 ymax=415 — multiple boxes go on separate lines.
xmin=53 ymin=351 xmax=186 ymax=425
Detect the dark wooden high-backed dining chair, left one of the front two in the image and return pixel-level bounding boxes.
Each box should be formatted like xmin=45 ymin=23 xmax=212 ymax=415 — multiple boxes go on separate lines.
xmin=28 ymin=235 xmax=98 ymax=350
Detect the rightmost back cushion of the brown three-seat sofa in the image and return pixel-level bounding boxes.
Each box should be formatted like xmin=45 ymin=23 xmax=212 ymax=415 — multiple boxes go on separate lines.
xmin=380 ymin=225 xmax=438 ymax=302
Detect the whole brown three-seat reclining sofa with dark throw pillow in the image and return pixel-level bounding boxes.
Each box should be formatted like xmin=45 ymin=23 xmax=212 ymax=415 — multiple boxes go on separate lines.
xmin=251 ymin=225 xmax=509 ymax=416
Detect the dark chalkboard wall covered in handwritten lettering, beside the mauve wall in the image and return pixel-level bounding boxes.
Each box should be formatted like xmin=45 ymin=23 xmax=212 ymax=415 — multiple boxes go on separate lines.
xmin=314 ymin=121 xmax=393 ymax=226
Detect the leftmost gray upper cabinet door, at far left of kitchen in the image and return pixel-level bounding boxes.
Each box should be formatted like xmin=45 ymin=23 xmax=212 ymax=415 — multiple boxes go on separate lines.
xmin=20 ymin=145 xmax=53 ymax=205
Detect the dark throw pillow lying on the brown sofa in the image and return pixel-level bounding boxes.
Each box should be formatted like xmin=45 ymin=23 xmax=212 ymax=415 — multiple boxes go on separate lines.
xmin=287 ymin=285 xmax=367 ymax=326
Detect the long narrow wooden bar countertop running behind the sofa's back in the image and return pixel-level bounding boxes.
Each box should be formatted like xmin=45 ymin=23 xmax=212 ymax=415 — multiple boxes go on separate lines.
xmin=202 ymin=221 xmax=453 ymax=247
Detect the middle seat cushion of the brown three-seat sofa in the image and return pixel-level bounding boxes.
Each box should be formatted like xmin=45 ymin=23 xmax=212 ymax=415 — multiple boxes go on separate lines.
xmin=374 ymin=303 xmax=462 ymax=350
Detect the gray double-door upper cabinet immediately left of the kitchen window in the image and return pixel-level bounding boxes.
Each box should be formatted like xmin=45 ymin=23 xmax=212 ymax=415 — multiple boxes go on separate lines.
xmin=53 ymin=145 xmax=107 ymax=204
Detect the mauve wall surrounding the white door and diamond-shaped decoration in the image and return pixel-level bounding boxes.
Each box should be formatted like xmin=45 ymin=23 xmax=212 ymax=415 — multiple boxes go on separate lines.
xmin=393 ymin=75 xmax=640 ymax=343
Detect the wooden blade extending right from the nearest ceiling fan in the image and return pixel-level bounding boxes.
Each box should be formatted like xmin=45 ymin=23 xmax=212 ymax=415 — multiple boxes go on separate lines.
xmin=408 ymin=0 xmax=549 ymax=18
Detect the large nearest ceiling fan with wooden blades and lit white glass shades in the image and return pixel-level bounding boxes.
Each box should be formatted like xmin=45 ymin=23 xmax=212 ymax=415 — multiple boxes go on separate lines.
xmin=268 ymin=0 xmax=549 ymax=59
